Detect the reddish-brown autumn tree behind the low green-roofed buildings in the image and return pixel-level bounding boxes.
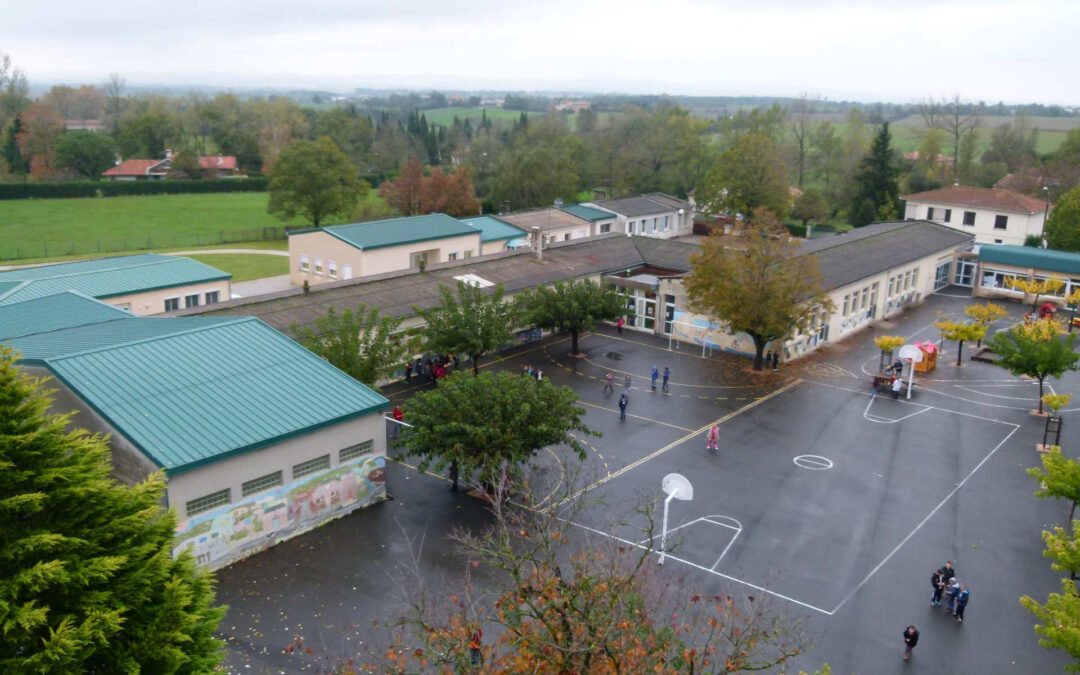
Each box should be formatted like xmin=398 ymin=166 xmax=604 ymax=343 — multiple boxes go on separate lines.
xmin=379 ymin=157 xmax=480 ymax=218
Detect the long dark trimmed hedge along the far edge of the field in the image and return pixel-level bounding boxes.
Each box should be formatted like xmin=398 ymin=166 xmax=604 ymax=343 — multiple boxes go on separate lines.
xmin=0 ymin=178 xmax=267 ymax=200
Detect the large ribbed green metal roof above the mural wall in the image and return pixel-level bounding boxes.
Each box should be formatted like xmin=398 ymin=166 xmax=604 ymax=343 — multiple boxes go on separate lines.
xmin=11 ymin=298 xmax=388 ymax=474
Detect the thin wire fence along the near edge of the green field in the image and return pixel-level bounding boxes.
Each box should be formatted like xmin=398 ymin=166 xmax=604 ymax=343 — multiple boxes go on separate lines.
xmin=0 ymin=227 xmax=295 ymax=260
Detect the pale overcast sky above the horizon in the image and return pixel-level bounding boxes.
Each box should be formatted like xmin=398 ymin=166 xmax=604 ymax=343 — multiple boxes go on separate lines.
xmin=0 ymin=0 xmax=1080 ymax=105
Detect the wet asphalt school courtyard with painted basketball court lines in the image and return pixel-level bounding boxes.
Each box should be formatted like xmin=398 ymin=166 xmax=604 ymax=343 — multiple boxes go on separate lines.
xmin=212 ymin=289 xmax=1080 ymax=674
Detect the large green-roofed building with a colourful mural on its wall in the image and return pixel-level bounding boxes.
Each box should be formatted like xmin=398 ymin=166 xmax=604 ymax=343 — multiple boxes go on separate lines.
xmin=0 ymin=293 xmax=388 ymax=568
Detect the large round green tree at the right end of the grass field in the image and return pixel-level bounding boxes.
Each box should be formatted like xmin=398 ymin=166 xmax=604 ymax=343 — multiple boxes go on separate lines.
xmin=267 ymin=136 xmax=370 ymax=227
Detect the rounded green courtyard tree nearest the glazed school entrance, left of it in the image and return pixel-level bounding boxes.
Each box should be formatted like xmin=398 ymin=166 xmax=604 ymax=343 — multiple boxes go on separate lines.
xmin=515 ymin=279 xmax=626 ymax=354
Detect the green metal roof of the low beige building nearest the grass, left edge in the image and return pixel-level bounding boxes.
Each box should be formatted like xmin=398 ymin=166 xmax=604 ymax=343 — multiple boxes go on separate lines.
xmin=0 ymin=254 xmax=232 ymax=305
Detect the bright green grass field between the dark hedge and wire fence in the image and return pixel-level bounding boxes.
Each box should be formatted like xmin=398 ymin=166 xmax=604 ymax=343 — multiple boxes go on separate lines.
xmin=0 ymin=192 xmax=378 ymax=260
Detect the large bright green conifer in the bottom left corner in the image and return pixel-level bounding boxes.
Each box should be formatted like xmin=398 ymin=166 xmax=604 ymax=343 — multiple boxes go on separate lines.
xmin=0 ymin=349 xmax=225 ymax=674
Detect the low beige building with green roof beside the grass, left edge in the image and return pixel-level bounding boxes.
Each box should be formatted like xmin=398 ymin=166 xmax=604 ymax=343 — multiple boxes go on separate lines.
xmin=0 ymin=254 xmax=232 ymax=316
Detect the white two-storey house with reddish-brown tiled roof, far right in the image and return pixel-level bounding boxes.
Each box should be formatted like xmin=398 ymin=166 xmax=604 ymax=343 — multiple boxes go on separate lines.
xmin=901 ymin=185 xmax=1050 ymax=246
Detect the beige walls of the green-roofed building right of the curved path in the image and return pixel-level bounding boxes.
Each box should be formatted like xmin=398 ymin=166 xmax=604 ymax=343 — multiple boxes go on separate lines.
xmin=288 ymin=232 xmax=482 ymax=286
